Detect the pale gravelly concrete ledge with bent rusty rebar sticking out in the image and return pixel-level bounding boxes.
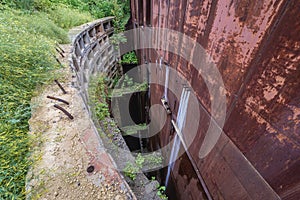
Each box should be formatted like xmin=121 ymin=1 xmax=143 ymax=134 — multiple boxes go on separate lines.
xmin=26 ymin=45 xmax=135 ymax=200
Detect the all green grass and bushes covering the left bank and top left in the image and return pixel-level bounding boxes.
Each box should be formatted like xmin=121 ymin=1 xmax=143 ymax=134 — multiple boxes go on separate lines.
xmin=0 ymin=0 xmax=129 ymax=199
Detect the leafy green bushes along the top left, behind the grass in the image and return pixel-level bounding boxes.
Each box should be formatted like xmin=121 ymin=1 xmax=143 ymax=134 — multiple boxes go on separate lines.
xmin=0 ymin=0 xmax=130 ymax=32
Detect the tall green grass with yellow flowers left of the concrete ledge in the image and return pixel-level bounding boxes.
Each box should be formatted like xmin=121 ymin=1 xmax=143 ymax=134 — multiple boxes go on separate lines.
xmin=0 ymin=6 xmax=58 ymax=199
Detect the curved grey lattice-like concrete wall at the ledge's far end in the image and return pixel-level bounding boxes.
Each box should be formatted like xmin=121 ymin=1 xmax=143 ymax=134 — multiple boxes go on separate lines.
xmin=70 ymin=17 xmax=122 ymax=114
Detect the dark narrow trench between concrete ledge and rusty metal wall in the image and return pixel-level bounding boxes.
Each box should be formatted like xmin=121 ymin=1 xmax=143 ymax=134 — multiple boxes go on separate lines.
xmin=105 ymin=65 xmax=207 ymax=199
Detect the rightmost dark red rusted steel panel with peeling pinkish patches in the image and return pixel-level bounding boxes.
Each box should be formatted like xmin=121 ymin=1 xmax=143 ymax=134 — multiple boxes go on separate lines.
xmin=225 ymin=1 xmax=300 ymax=199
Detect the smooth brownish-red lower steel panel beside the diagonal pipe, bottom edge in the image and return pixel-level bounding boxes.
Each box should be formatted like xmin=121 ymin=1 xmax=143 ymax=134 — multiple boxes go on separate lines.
xmin=187 ymin=108 xmax=278 ymax=199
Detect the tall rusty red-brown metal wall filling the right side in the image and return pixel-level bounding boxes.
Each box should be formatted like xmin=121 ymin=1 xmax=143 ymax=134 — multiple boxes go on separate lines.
xmin=131 ymin=0 xmax=300 ymax=199
